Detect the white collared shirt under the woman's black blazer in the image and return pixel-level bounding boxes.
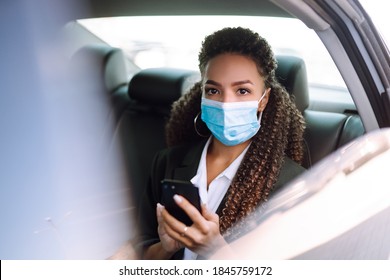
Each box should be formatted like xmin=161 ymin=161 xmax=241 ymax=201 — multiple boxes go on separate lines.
xmin=183 ymin=136 xmax=249 ymax=260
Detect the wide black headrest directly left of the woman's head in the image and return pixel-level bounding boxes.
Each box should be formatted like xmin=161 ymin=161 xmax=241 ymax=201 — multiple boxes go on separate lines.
xmin=129 ymin=67 xmax=200 ymax=105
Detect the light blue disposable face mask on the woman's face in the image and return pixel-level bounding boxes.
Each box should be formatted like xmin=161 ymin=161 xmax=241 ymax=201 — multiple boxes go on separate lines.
xmin=201 ymin=93 xmax=265 ymax=146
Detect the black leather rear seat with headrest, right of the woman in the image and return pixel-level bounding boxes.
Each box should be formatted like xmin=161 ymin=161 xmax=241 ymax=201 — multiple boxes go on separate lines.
xmin=276 ymin=56 xmax=365 ymax=168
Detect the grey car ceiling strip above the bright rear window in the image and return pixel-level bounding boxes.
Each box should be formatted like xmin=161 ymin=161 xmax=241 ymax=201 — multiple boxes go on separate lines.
xmin=80 ymin=0 xmax=291 ymax=17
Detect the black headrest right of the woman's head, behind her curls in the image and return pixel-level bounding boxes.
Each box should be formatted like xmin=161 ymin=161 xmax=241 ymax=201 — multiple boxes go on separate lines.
xmin=275 ymin=55 xmax=309 ymax=112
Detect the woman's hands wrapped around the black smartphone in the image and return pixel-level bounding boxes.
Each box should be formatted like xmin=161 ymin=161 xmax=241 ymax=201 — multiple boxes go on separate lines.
xmin=159 ymin=195 xmax=226 ymax=257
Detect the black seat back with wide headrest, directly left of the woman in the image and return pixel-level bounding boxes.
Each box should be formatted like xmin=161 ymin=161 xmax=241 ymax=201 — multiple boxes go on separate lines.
xmin=114 ymin=68 xmax=199 ymax=211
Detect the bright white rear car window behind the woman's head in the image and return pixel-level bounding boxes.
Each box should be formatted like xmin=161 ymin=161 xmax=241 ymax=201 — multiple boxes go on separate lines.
xmin=79 ymin=16 xmax=348 ymax=92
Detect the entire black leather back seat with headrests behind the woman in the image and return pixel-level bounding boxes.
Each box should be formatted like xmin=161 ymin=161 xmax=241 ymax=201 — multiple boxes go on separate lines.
xmin=69 ymin=42 xmax=364 ymax=221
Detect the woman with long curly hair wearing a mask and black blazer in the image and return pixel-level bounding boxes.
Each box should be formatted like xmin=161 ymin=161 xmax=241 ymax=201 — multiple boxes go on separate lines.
xmin=138 ymin=27 xmax=304 ymax=259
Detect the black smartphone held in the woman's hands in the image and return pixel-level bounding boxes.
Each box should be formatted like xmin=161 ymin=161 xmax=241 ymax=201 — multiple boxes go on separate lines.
xmin=161 ymin=179 xmax=201 ymax=226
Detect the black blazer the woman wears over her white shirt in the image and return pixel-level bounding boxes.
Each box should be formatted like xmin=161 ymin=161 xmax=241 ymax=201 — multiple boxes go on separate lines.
xmin=135 ymin=140 xmax=305 ymax=259
